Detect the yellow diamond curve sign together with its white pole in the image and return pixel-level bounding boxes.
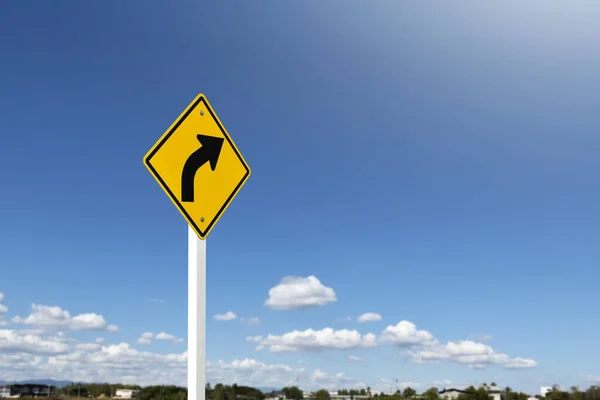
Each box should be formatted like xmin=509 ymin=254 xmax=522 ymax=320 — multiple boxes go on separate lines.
xmin=144 ymin=94 xmax=250 ymax=400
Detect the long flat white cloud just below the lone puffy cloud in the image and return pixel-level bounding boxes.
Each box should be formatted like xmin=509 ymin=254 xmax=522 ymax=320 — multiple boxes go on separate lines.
xmin=246 ymin=328 xmax=376 ymax=353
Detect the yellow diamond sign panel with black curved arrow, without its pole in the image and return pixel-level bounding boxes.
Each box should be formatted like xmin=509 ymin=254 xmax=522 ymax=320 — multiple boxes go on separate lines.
xmin=144 ymin=94 xmax=250 ymax=239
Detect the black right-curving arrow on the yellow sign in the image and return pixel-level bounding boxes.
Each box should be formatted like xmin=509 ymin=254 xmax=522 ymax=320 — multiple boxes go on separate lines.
xmin=181 ymin=135 xmax=223 ymax=202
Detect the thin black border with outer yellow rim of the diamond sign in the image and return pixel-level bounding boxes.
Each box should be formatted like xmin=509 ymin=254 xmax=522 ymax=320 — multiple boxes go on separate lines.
xmin=144 ymin=96 xmax=250 ymax=239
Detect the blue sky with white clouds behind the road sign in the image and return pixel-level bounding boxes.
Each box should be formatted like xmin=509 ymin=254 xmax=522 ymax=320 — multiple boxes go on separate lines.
xmin=0 ymin=1 xmax=600 ymax=394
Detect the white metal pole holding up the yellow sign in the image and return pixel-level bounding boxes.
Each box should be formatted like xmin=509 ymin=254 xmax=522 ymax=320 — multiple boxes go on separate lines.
xmin=188 ymin=226 xmax=206 ymax=400
